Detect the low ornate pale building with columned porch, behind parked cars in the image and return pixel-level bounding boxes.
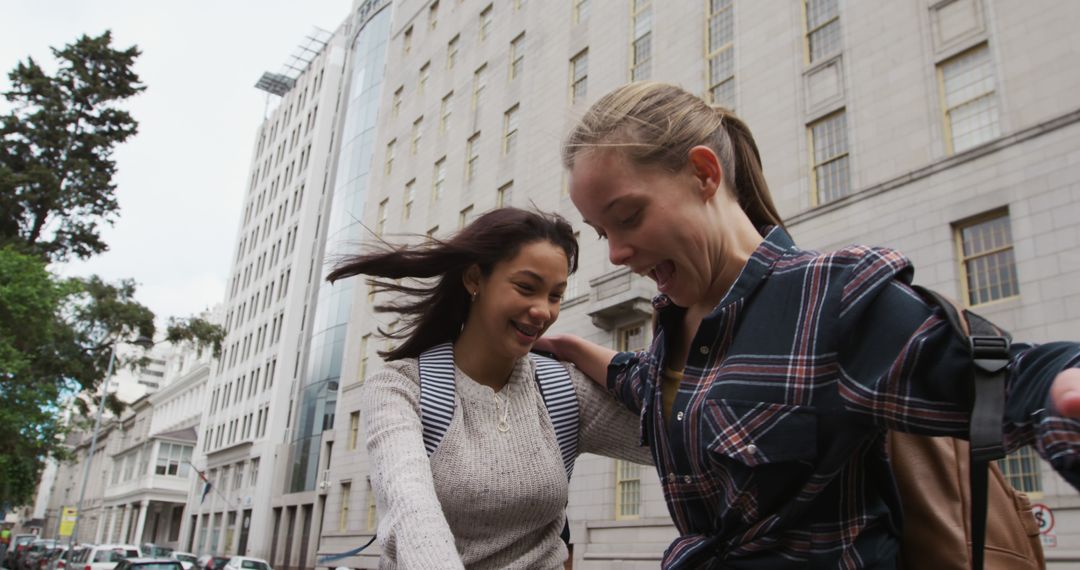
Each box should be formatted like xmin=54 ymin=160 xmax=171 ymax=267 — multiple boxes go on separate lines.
xmin=44 ymin=336 xmax=213 ymax=548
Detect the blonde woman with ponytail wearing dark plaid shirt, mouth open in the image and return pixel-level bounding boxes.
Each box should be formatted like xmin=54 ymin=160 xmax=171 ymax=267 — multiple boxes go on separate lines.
xmin=543 ymin=82 xmax=1080 ymax=569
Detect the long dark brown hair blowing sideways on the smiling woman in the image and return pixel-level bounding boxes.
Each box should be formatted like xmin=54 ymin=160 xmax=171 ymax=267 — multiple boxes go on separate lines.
xmin=326 ymin=207 xmax=578 ymax=361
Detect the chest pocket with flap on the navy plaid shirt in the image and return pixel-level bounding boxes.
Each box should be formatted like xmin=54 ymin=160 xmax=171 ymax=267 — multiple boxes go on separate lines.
xmin=702 ymin=399 xmax=818 ymax=467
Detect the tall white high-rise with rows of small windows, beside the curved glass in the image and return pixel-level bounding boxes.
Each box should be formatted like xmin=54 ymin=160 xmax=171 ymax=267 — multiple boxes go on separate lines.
xmin=179 ymin=22 xmax=354 ymax=568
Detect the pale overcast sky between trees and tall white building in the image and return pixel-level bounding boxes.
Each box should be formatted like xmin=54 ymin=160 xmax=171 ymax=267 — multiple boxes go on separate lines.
xmin=0 ymin=0 xmax=352 ymax=325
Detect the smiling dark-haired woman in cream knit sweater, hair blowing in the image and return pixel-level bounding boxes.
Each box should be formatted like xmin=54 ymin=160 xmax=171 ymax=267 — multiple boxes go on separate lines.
xmin=328 ymin=208 xmax=650 ymax=569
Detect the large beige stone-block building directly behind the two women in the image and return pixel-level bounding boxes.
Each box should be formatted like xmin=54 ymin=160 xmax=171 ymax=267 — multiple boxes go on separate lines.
xmin=321 ymin=0 xmax=1080 ymax=568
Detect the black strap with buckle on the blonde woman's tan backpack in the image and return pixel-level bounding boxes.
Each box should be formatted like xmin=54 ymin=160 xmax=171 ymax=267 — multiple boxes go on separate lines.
xmin=915 ymin=286 xmax=1011 ymax=570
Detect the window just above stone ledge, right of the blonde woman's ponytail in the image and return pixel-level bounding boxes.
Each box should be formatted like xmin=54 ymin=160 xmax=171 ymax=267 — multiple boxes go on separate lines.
xmin=809 ymin=109 xmax=851 ymax=205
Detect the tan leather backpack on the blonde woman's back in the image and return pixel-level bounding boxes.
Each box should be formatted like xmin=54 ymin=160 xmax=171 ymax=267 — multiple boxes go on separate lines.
xmin=887 ymin=287 xmax=1047 ymax=570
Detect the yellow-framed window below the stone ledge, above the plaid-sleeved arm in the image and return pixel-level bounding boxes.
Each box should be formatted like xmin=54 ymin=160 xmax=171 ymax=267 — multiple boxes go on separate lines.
xmin=956 ymin=211 xmax=1020 ymax=307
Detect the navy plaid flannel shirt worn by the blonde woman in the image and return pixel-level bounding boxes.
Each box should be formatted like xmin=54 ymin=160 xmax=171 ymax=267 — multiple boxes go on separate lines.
xmin=607 ymin=228 xmax=1080 ymax=570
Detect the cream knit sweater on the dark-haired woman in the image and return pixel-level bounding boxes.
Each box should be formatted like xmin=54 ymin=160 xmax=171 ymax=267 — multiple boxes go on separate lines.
xmin=361 ymin=357 xmax=652 ymax=570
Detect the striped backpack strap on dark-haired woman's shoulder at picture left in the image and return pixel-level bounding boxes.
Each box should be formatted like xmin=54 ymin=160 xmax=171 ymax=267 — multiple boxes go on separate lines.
xmin=419 ymin=342 xmax=456 ymax=457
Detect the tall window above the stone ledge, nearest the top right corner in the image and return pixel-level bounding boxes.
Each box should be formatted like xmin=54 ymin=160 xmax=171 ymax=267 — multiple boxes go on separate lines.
xmin=937 ymin=43 xmax=1001 ymax=153
